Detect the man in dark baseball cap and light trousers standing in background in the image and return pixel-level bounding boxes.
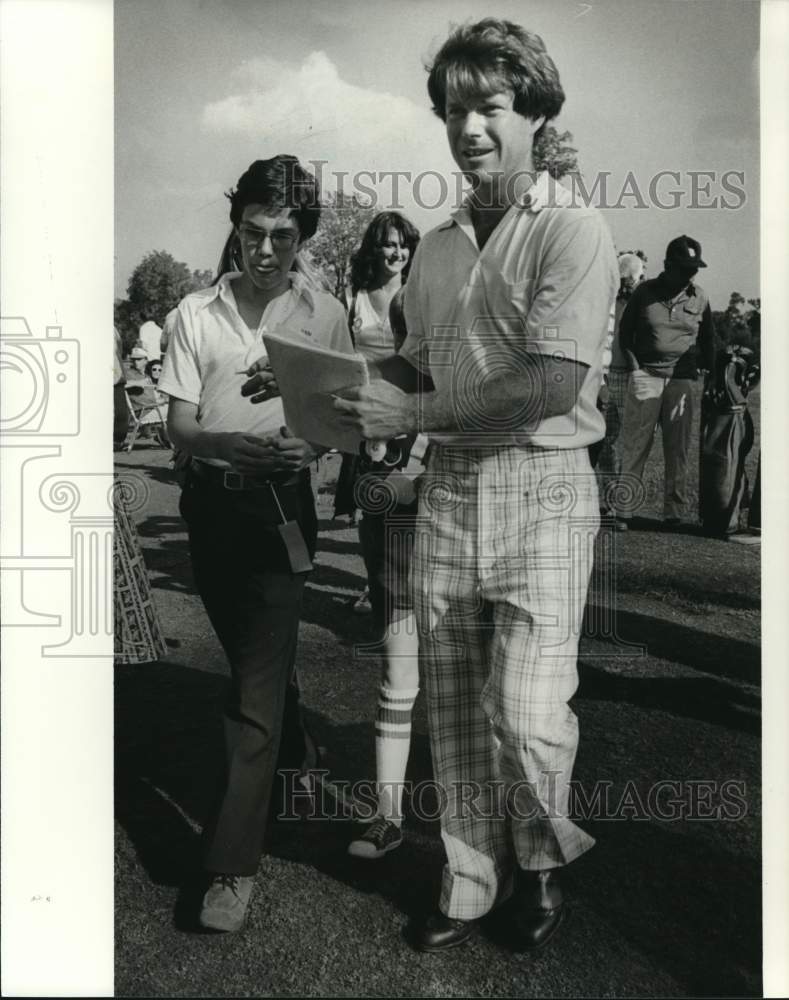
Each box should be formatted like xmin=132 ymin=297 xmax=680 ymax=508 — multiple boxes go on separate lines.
xmin=618 ymin=236 xmax=715 ymax=526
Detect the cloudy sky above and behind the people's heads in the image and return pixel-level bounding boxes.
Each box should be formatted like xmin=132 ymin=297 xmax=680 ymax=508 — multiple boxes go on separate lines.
xmin=115 ymin=0 xmax=760 ymax=309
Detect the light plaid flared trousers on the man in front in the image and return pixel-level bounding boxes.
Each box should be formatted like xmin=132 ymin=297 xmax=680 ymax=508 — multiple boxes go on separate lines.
xmin=412 ymin=445 xmax=600 ymax=919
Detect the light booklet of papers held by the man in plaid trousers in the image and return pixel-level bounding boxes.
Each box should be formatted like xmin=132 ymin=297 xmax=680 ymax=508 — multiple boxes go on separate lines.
xmin=263 ymin=333 xmax=370 ymax=453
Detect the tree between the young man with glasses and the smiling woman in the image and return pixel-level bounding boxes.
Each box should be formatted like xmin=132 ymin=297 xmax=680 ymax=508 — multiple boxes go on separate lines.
xmin=305 ymin=192 xmax=375 ymax=299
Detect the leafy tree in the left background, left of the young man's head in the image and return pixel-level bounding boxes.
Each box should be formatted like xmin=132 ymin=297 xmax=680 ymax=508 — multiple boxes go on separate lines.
xmin=114 ymin=250 xmax=214 ymax=350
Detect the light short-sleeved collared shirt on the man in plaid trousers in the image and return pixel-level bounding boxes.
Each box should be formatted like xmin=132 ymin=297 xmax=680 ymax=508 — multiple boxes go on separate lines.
xmin=400 ymin=173 xmax=619 ymax=448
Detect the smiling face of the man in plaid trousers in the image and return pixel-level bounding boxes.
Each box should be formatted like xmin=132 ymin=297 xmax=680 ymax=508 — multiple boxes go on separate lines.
xmin=446 ymin=88 xmax=544 ymax=202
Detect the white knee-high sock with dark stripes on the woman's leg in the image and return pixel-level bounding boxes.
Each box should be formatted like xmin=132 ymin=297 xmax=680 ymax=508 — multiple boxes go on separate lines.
xmin=375 ymin=684 xmax=419 ymax=826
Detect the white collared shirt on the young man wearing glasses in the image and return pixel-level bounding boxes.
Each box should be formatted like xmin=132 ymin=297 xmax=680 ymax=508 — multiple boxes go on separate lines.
xmin=159 ymin=272 xmax=353 ymax=465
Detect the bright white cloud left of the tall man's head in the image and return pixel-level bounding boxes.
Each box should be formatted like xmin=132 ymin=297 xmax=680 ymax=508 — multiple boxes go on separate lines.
xmin=202 ymin=52 xmax=455 ymax=215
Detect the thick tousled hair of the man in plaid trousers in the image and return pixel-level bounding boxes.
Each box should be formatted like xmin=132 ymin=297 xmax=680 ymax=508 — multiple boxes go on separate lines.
xmin=427 ymin=17 xmax=564 ymax=136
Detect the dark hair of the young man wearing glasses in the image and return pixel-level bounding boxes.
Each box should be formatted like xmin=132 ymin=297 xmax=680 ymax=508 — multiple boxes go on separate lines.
xmin=225 ymin=153 xmax=321 ymax=240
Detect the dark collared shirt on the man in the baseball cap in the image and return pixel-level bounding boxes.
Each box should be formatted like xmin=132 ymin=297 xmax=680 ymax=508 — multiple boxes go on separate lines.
xmin=619 ymin=275 xmax=715 ymax=378
